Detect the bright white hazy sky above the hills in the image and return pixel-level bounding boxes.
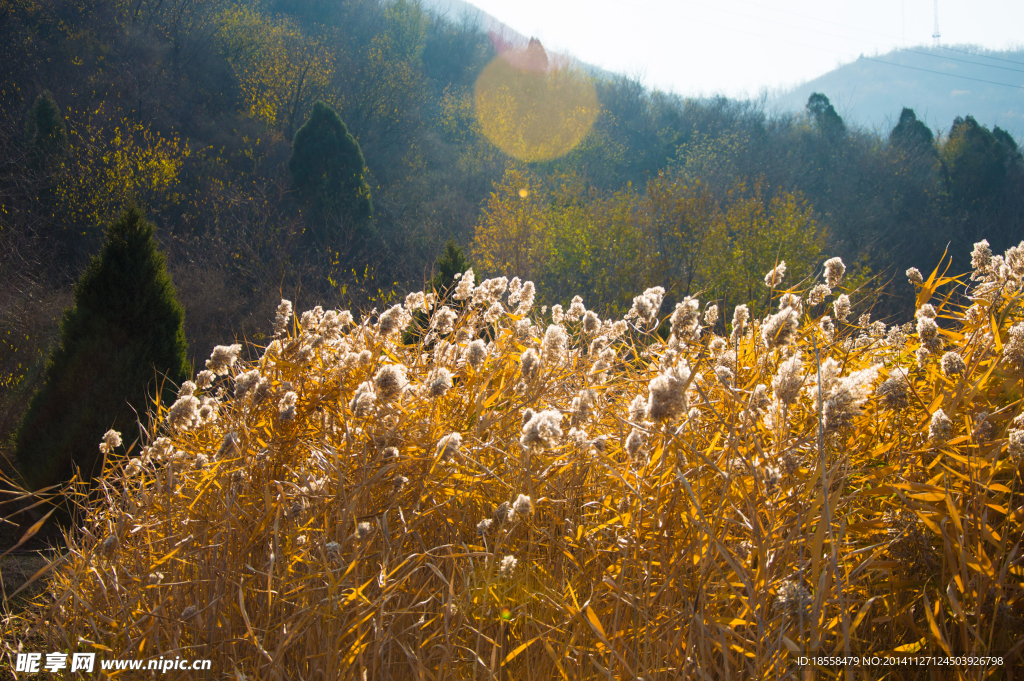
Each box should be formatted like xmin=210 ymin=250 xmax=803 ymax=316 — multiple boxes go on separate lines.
xmin=452 ymin=0 xmax=1024 ymax=96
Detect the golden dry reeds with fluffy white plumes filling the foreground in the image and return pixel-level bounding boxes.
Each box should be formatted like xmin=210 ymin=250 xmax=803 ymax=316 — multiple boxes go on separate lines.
xmin=3 ymin=244 xmax=1024 ymax=680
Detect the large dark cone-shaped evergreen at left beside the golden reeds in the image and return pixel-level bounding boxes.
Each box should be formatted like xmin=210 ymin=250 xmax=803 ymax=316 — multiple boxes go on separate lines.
xmin=15 ymin=208 xmax=188 ymax=490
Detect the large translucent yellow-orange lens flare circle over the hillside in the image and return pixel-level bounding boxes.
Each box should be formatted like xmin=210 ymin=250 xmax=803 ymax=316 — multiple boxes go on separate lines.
xmin=474 ymin=49 xmax=600 ymax=163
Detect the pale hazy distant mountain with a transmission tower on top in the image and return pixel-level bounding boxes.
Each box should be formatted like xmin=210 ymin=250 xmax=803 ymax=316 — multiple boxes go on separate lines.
xmin=768 ymin=45 xmax=1024 ymax=140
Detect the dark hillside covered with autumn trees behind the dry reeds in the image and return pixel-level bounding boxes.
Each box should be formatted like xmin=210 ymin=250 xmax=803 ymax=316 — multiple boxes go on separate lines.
xmin=0 ymin=0 xmax=1024 ymax=473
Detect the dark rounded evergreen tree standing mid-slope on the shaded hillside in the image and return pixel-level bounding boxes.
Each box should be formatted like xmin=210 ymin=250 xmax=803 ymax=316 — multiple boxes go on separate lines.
xmin=288 ymin=101 xmax=374 ymax=241
